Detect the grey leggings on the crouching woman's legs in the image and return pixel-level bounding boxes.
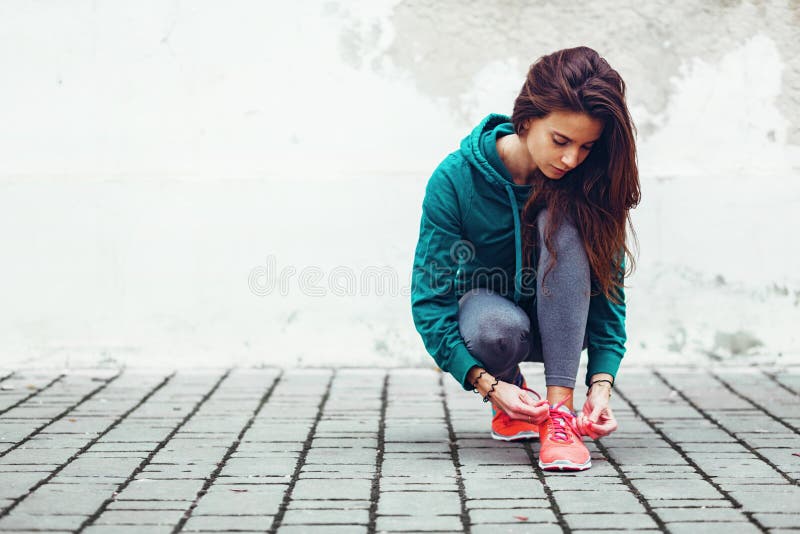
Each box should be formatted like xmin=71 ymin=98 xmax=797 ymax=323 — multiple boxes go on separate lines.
xmin=458 ymin=210 xmax=590 ymax=388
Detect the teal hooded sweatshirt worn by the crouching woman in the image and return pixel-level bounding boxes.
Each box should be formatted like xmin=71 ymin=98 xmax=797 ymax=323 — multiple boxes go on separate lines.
xmin=411 ymin=115 xmax=626 ymax=390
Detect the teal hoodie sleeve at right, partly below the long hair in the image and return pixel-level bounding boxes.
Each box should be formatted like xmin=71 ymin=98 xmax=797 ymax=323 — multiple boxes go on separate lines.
xmin=586 ymin=256 xmax=627 ymax=386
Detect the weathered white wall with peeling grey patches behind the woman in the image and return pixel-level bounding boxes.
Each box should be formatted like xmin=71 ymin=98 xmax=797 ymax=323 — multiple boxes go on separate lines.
xmin=0 ymin=0 xmax=800 ymax=365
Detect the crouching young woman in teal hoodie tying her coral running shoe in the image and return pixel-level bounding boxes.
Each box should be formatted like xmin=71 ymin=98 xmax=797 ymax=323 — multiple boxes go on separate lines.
xmin=411 ymin=47 xmax=640 ymax=470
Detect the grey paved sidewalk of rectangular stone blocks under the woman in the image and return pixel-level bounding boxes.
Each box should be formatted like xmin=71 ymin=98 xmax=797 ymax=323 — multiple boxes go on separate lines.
xmin=0 ymin=367 xmax=800 ymax=534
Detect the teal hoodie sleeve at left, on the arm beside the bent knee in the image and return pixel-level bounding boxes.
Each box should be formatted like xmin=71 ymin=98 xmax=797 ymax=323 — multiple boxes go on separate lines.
xmin=411 ymin=160 xmax=482 ymax=390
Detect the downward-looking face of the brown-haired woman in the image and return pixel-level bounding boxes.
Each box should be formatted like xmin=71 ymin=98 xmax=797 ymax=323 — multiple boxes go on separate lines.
xmin=521 ymin=111 xmax=603 ymax=180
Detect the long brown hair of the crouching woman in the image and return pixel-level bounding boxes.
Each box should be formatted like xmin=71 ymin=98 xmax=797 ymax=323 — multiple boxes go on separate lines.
xmin=511 ymin=46 xmax=641 ymax=302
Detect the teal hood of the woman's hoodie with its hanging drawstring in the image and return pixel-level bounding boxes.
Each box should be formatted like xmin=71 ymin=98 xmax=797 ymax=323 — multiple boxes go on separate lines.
xmin=461 ymin=114 xmax=531 ymax=304
